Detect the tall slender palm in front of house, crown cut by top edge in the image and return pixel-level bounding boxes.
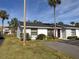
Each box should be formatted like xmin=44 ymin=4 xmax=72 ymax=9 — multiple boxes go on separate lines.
xmin=48 ymin=0 xmax=61 ymax=37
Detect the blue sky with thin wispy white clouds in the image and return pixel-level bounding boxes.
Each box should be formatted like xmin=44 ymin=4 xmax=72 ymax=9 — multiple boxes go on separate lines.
xmin=0 ymin=0 xmax=79 ymax=25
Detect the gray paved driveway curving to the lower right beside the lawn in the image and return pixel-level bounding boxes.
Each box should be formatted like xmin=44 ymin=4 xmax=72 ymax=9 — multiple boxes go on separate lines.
xmin=44 ymin=42 xmax=79 ymax=59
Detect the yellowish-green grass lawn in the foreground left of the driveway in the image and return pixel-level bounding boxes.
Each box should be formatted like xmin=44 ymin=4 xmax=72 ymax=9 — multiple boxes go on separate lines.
xmin=0 ymin=36 xmax=72 ymax=59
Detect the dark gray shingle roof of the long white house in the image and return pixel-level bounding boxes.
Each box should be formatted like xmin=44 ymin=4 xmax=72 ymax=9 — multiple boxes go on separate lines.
xmin=19 ymin=21 xmax=79 ymax=27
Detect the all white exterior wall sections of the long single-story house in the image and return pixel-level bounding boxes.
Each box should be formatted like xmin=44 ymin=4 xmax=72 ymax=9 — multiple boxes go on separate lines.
xmin=23 ymin=29 xmax=79 ymax=40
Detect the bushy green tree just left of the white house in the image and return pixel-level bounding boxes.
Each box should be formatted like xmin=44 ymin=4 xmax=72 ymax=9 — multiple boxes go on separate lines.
xmin=8 ymin=18 xmax=18 ymax=33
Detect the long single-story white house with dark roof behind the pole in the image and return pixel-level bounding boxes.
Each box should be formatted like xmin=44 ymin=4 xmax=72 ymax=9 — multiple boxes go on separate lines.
xmin=17 ymin=22 xmax=79 ymax=40
